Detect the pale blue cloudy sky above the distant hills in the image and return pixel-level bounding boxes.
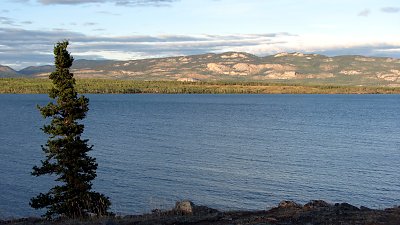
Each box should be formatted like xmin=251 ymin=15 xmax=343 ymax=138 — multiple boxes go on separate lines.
xmin=0 ymin=0 xmax=400 ymax=70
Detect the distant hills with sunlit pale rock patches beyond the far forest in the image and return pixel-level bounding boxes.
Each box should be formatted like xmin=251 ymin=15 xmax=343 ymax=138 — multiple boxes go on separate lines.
xmin=0 ymin=52 xmax=400 ymax=86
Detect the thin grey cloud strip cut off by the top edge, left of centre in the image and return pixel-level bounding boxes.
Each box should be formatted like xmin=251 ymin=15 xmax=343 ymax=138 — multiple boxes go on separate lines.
xmin=38 ymin=0 xmax=178 ymax=6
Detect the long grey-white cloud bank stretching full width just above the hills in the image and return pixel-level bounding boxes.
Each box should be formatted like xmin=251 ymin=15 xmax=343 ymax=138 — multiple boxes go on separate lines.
xmin=0 ymin=27 xmax=400 ymax=69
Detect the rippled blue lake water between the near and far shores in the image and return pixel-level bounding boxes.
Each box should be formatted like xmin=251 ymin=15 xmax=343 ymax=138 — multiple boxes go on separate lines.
xmin=0 ymin=94 xmax=400 ymax=218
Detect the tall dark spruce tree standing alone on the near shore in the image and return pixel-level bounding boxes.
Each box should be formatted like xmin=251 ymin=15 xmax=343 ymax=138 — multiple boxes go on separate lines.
xmin=29 ymin=41 xmax=111 ymax=219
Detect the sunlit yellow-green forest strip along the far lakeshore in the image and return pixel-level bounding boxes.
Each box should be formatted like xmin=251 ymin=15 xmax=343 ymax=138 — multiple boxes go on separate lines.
xmin=0 ymin=78 xmax=400 ymax=94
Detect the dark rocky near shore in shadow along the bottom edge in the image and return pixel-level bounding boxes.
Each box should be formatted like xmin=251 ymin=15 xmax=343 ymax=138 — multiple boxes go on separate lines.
xmin=0 ymin=200 xmax=400 ymax=225
